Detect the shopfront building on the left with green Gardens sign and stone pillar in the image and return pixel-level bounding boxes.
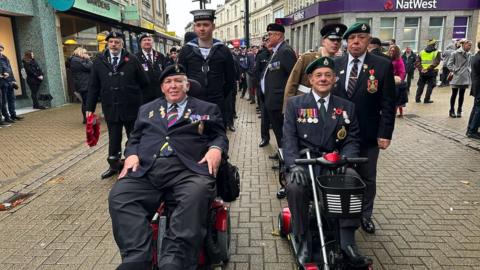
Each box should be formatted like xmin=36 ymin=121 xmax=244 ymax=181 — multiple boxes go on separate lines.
xmin=0 ymin=0 xmax=180 ymax=108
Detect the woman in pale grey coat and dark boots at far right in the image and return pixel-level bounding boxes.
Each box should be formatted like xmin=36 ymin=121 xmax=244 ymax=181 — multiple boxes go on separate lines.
xmin=447 ymin=40 xmax=472 ymax=118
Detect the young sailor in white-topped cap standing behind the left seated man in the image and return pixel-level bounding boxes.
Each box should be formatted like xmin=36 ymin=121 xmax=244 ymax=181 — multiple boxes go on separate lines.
xmin=178 ymin=9 xmax=235 ymax=121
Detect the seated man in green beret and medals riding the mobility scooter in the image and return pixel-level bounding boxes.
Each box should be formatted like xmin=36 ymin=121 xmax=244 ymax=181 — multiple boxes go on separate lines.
xmin=282 ymin=57 xmax=371 ymax=266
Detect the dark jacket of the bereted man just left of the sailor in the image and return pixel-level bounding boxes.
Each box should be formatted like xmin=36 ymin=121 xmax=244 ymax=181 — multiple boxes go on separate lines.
xmin=135 ymin=50 xmax=166 ymax=104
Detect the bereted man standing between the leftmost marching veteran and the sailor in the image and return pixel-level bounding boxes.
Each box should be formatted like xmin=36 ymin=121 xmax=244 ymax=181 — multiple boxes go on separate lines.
xmin=135 ymin=33 xmax=166 ymax=104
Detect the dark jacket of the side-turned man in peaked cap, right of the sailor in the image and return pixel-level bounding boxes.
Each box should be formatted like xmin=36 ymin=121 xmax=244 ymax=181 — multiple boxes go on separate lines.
xmin=260 ymin=41 xmax=297 ymax=111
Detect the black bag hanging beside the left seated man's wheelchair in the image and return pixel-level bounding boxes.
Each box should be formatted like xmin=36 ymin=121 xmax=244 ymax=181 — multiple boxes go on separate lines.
xmin=216 ymin=159 xmax=240 ymax=202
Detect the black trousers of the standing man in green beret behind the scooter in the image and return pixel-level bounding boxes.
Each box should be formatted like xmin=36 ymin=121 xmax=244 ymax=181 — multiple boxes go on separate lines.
xmin=357 ymin=145 xmax=380 ymax=218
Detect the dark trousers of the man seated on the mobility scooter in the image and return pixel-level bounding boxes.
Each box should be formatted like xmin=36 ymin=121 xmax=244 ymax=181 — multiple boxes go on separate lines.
xmin=286 ymin=166 xmax=360 ymax=245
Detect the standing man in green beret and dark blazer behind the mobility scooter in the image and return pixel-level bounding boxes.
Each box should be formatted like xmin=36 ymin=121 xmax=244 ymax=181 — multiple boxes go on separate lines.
xmin=333 ymin=23 xmax=395 ymax=233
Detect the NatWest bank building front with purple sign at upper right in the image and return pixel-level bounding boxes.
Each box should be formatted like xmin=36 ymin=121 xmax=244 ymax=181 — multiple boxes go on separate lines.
xmin=287 ymin=0 xmax=480 ymax=52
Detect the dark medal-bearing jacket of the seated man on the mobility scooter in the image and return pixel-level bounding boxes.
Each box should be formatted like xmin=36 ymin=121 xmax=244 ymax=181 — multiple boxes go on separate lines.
xmin=282 ymin=93 xmax=360 ymax=167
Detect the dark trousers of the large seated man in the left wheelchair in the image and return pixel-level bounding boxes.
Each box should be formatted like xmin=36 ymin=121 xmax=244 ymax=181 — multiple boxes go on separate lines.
xmin=108 ymin=156 xmax=215 ymax=270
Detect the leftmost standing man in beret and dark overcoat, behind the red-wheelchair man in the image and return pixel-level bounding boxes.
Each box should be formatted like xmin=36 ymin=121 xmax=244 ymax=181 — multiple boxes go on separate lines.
xmin=86 ymin=31 xmax=149 ymax=179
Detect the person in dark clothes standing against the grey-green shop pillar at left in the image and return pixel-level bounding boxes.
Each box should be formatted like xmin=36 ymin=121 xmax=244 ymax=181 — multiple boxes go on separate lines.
xmin=22 ymin=50 xmax=46 ymax=110
